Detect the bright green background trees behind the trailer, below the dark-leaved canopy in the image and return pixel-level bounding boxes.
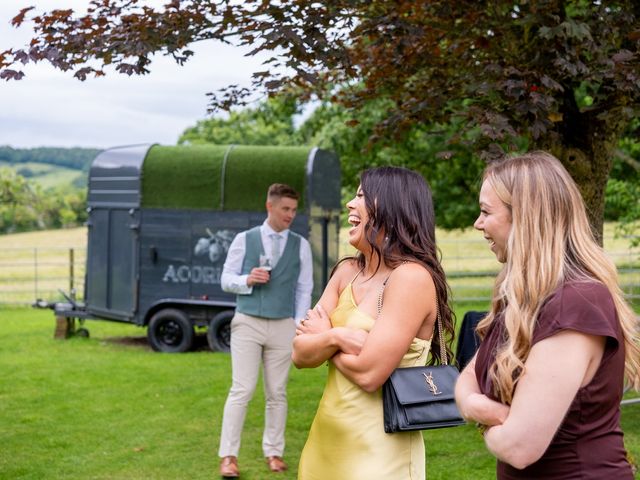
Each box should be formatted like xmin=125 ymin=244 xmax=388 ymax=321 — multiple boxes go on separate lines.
xmin=178 ymin=97 xmax=640 ymax=232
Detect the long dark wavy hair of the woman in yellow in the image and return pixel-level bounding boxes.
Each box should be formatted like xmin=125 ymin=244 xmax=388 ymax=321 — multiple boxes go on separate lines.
xmin=344 ymin=167 xmax=455 ymax=364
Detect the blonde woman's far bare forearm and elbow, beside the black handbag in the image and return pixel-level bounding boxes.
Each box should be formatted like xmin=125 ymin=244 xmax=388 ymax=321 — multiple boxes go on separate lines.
xmin=456 ymin=355 xmax=509 ymax=426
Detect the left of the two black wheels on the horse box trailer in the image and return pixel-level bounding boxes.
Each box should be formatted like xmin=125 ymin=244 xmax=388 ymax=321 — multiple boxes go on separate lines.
xmin=147 ymin=308 xmax=194 ymax=353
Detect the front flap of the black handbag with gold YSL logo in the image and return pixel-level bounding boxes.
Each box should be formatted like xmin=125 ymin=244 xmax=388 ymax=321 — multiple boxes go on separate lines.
xmin=389 ymin=365 xmax=459 ymax=405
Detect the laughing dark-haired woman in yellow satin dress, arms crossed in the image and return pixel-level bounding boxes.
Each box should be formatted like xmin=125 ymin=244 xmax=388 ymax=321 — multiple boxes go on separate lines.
xmin=292 ymin=167 xmax=453 ymax=480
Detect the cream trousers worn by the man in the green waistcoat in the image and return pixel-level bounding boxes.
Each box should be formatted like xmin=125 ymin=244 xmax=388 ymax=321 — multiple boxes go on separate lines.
xmin=218 ymin=312 xmax=296 ymax=457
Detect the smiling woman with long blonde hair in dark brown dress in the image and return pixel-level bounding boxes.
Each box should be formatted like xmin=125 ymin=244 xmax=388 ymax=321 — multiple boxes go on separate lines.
xmin=456 ymin=152 xmax=640 ymax=480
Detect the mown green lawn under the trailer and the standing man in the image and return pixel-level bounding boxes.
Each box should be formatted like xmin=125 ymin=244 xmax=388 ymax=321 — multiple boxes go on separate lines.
xmin=0 ymin=304 xmax=640 ymax=480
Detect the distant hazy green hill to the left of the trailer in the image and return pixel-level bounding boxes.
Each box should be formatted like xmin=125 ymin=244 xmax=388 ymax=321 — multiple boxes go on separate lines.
xmin=0 ymin=146 xmax=100 ymax=190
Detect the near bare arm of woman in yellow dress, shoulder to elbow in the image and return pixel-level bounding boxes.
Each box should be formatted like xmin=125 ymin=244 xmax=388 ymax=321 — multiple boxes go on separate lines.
xmin=331 ymin=263 xmax=436 ymax=392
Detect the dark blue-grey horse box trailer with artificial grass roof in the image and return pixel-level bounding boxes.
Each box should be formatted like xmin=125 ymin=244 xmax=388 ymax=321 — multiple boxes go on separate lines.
xmin=50 ymin=145 xmax=341 ymax=352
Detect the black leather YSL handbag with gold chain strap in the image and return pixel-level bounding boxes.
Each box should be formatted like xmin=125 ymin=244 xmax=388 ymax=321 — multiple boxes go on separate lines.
xmin=378 ymin=286 xmax=465 ymax=433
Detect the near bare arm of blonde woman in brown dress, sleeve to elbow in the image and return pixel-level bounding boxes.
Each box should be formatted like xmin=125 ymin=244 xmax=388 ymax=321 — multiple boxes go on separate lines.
xmin=485 ymin=330 xmax=605 ymax=468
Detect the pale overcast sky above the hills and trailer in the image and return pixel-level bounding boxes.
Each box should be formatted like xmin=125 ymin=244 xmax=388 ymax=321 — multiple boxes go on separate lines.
xmin=0 ymin=0 xmax=268 ymax=148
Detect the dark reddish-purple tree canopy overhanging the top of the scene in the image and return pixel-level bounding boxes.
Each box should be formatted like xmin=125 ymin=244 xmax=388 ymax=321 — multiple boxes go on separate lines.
xmin=0 ymin=0 xmax=640 ymax=240
